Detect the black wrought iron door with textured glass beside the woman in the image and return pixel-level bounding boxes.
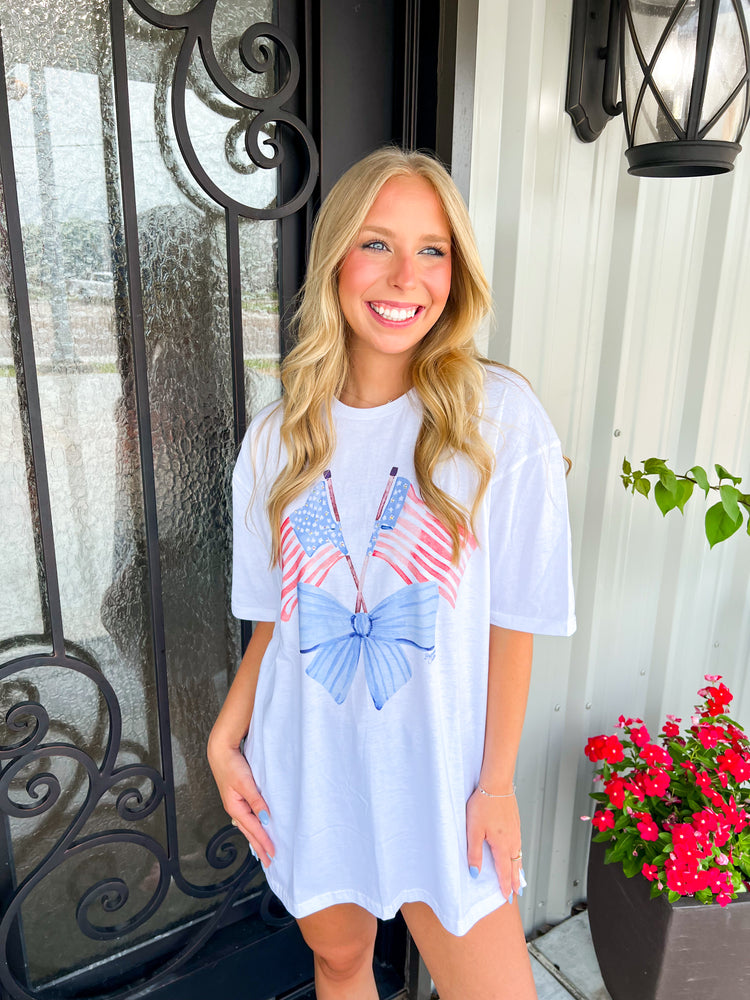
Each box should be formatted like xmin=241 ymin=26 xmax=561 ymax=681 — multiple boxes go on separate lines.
xmin=0 ymin=0 xmax=452 ymax=1000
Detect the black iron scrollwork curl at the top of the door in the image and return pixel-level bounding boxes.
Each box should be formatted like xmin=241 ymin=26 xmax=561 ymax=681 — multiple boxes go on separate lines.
xmin=129 ymin=0 xmax=319 ymax=219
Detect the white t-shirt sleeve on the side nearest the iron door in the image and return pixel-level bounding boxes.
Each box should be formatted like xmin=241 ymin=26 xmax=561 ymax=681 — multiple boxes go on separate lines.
xmin=232 ymin=418 xmax=281 ymax=621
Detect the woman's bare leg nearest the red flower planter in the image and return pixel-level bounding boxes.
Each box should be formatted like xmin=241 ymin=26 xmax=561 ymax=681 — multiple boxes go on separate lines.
xmin=401 ymin=903 xmax=536 ymax=1000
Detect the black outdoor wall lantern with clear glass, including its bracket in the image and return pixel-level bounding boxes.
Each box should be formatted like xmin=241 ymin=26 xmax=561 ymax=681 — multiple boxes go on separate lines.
xmin=565 ymin=0 xmax=750 ymax=177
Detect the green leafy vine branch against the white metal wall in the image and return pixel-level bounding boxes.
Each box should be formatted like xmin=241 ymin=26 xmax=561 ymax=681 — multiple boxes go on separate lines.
xmin=620 ymin=458 xmax=750 ymax=548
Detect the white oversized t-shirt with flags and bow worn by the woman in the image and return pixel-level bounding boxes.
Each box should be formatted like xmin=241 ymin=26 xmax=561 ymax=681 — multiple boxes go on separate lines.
xmin=232 ymin=368 xmax=575 ymax=934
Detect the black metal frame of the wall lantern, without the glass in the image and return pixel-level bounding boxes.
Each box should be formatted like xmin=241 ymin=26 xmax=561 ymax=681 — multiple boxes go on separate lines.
xmin=565 ymin=0 xmax=750 ymax=177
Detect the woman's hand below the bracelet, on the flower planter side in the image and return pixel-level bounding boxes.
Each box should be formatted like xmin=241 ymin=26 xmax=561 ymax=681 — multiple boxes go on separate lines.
xmin=466 ymin=788 xmax=523 ymax=903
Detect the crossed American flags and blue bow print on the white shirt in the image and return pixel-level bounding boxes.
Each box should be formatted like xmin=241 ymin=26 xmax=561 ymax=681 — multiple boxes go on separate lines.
xmin=281 ymin=467 xmax=477 ymax=709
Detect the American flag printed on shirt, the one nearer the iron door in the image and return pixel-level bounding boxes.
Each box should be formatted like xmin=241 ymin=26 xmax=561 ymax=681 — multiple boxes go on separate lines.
xmin=281 ymin=473 xmax=348 ymax=622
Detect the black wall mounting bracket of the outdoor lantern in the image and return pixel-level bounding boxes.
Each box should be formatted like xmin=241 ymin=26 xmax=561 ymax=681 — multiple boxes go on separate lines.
xmin=565 ymin=0 xmax=622 ymax=142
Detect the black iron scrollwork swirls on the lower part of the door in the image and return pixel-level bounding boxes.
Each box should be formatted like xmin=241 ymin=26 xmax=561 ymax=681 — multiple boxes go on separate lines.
xmin=0 ymin=654 xmax=270 ymax=1000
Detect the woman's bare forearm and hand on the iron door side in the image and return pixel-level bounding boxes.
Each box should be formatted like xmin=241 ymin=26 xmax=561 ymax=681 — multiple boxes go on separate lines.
xmin=207 ymin=622 xmax=274 ymax=868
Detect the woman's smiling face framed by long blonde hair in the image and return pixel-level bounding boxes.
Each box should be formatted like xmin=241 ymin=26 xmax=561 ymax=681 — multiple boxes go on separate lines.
xmin=338 ymin=176 xmax=451 ymax=374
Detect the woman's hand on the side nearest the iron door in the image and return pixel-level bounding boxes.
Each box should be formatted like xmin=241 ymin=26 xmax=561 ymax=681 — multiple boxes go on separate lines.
xmin=208 ymin=739 xmax=275 ymax=868
